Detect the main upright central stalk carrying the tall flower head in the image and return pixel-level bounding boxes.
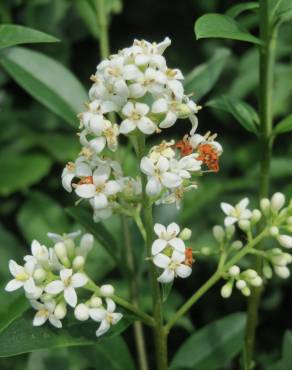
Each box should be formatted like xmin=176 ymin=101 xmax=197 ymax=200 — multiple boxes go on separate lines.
xmin=134 ymin=133 xmax=167 ymax=370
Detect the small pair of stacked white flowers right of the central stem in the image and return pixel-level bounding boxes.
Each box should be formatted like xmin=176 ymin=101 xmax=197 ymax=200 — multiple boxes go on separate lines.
xmin=151 ymin=222 xmax=193 ymax=284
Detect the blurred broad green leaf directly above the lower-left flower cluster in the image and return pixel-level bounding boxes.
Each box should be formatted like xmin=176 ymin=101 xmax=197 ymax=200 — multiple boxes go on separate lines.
xmin=17 ymin=192 xmax=70 ymax=243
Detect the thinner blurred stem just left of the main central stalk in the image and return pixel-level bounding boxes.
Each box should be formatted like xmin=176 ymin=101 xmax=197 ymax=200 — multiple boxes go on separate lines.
xmin=121 ymin=216 xmax=148 ymax=370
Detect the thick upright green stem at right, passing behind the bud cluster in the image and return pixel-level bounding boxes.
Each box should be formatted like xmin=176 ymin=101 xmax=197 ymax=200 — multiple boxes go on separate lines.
xmin=244 ymin=0 xmax=277 ymax=370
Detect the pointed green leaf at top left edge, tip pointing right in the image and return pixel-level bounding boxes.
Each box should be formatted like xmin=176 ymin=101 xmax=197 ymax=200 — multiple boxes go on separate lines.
xmin=0 ymin=24 xmax=60 ymax=49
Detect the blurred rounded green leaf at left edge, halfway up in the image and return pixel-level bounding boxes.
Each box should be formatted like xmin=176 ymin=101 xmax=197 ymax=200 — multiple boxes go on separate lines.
xmin=0 ymin=154 xmax=52 ymax=196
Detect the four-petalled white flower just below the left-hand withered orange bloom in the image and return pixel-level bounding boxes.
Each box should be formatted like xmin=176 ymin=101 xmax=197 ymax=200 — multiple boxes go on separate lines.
xmin=75 ymin=167 xmax=121 ymax=209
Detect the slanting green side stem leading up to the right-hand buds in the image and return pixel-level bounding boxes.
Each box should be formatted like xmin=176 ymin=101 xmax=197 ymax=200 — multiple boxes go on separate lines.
xmin=165 ymin=230 xmax=267 ymax=333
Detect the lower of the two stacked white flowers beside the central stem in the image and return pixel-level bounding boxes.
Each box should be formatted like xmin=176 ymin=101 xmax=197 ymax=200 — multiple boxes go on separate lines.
xmin=153 ymin=251 xmax=192 ymax=283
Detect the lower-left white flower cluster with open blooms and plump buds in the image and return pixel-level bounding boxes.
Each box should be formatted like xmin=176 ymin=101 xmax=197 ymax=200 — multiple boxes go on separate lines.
xmin=5 ymin=232 xmax=122 ymax=336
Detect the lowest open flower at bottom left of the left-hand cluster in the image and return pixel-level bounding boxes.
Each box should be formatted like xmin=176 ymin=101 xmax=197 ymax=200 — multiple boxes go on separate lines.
xmin=30 ymin=300 xmax=62 ymax=328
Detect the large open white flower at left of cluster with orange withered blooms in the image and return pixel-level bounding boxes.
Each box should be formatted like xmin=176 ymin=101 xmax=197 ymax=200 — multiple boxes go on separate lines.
xmin=140 ymin=156 xmax=182 ymax=196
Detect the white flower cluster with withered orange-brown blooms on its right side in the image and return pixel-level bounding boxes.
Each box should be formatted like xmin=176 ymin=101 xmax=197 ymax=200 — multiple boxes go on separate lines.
xmin=140 ymin=133 xmax=222 ymax=207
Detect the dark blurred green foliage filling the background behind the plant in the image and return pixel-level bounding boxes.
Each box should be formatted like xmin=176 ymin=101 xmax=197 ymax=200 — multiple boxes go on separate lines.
xmin=0 ymin=0 xmax=292 ymax=370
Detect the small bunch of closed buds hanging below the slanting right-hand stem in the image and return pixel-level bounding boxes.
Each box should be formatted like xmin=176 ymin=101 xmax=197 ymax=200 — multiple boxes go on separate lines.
xmin=221 ymin=265 xmax=263 ymax=298
